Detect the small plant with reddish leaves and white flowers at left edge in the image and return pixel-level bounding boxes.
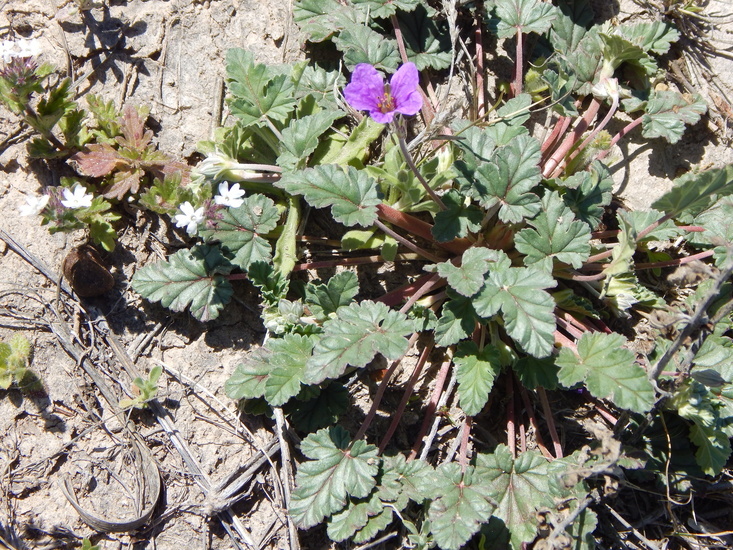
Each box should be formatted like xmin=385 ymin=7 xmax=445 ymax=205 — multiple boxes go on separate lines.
xmin=0 ymin=41 xmax=194 ymax=251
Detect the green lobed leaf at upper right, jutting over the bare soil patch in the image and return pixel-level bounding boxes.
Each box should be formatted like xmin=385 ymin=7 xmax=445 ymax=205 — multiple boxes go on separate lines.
xmin=641 ymin=90 xmax=707 ymax=143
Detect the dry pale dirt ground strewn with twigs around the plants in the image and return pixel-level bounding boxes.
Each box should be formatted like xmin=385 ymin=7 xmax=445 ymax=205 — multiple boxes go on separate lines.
xmin=0 ymin=0 xmax=733 ymax=550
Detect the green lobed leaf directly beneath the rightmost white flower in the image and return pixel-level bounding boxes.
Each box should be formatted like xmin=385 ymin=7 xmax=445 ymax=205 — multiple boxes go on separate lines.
xmin=199 ymin=194 xmax=280 ymax=270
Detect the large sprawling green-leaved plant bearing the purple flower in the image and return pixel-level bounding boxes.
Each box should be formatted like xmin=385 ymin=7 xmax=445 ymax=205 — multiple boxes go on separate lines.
xmin=127 ymin=0 xmax=733 ymax=549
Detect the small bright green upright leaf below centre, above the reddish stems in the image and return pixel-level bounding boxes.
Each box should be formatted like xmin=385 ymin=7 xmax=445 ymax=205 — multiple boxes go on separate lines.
xmin=453 ymin=342 xmax=501 ymax=416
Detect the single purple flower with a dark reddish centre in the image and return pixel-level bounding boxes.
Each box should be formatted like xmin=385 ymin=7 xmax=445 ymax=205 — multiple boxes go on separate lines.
xmin=344 ymin=63 xmax=422 ymax=124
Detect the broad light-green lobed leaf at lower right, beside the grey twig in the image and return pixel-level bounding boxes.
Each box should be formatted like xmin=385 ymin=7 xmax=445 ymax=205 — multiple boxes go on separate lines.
xmin=557 ymin=332 xmax=655 ymax=413
